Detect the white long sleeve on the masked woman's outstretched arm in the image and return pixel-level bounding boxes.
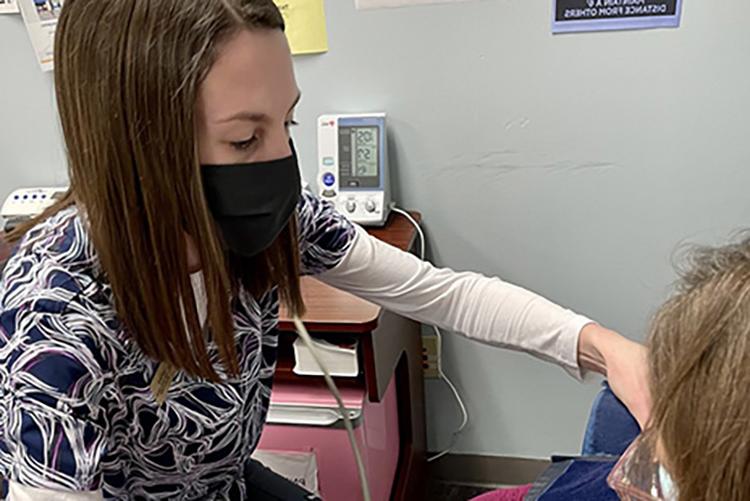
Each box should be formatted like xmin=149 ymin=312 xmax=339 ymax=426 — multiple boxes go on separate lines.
xmin=317 ymin=227 xmax=592 ymax=378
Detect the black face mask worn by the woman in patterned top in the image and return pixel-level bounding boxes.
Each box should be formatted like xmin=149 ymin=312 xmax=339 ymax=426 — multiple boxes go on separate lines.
xmin=201 ymin=142 xmax=301 ymax=257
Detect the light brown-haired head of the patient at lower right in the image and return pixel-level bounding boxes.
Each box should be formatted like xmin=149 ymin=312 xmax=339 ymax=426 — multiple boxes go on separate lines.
xmin=648 ymin=235 xmax=750 ymax=501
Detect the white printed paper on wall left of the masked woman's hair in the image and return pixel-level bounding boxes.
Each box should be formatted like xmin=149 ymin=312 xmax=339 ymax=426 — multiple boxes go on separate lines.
xmin=17 ymin=0 xmax=64 ymax=71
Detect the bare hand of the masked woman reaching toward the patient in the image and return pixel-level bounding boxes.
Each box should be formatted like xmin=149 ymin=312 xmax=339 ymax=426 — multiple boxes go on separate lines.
xmin=578 ymin=324 xmax=651 ymax=428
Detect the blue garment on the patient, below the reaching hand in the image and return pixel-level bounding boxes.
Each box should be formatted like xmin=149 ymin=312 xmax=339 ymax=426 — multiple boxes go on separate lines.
xmin=525 ymin=383 xmax=640 ymax=501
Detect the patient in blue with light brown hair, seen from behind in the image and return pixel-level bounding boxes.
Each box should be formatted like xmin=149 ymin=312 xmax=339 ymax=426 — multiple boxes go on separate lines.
xmin=476 ymin=238 xmax=750 ymax=501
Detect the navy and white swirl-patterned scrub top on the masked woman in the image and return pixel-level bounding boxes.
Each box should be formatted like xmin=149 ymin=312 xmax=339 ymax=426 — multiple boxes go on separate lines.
xmin=0 ymin=192 xmax=355 ymax=500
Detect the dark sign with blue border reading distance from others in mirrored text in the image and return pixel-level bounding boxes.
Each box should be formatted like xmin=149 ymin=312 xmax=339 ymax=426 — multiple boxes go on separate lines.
xmin=552 ymin=0 xmax=682 ymax=33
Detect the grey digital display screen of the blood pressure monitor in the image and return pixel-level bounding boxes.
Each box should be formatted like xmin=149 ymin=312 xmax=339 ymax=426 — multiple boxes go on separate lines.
xmin=339 ymin=125 xmax=380 ymax=188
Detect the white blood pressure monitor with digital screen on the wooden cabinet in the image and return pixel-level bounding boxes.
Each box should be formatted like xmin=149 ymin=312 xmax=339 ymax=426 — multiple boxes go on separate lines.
xmin=318 ymin=113 xmax=391 ymax=226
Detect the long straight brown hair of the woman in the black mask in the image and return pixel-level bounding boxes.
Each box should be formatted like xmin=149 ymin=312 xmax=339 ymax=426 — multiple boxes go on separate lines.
xmin=12 ymin=0 xmax=303 ymax=380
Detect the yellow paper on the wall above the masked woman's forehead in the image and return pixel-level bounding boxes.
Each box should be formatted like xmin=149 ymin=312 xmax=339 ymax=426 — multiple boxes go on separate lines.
xmin=274 ymin=0 xmax=328 ymax=55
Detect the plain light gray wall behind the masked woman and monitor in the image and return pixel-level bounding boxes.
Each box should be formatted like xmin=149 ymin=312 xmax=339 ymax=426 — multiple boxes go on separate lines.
xmin=0 ymin=0 xmax=750 ymax=457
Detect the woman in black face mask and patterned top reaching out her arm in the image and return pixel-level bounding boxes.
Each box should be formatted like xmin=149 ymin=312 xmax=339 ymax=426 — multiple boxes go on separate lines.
xmin=0 ymin=0 xmax=649 ymax=500
